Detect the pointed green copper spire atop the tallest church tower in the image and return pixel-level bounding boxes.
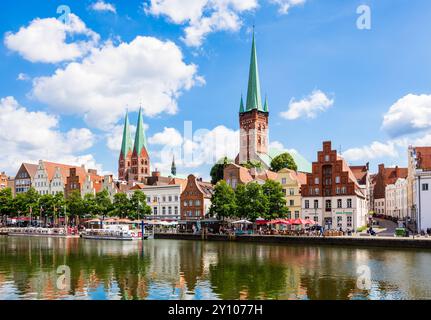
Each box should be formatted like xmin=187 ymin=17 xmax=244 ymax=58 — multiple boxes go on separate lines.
xmin=246 ymin=31 xmax=264 ymax=111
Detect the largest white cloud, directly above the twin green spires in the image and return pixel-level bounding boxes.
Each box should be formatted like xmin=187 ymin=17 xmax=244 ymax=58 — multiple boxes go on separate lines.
xmin=32 ymin=36 xmax=203 ymax=130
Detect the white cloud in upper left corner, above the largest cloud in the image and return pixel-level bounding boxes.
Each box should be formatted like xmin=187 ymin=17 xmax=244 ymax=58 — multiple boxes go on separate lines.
xmin=4 ymin=14 xmax=100 ymax=63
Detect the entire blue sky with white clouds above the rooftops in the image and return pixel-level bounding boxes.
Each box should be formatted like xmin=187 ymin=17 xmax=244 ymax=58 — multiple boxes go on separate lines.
xmin=0 ymin=0 xmax=431 ymax=177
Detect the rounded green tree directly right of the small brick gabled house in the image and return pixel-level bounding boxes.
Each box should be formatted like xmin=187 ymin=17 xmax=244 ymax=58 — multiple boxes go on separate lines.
xmin=210 ymin=180 xmax=237 ymax=219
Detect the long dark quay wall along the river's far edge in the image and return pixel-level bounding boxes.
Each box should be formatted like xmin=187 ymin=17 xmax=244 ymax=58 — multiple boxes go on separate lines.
xmin=154 ymin=233 xmax=431 ymax=249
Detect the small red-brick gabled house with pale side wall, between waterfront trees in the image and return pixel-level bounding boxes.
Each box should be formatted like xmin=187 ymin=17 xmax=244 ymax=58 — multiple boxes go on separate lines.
xmin=181 ymin=175 xmax=214 ymax=221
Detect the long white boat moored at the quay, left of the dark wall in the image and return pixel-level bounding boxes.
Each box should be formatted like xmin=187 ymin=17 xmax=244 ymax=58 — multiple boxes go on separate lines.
xmin=81 ymin=225 xmax=148 ymax=241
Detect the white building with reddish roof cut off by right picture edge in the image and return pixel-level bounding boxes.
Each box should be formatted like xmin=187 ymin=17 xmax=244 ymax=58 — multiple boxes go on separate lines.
xmin=408 ymin=147 xmax=431 ymax=231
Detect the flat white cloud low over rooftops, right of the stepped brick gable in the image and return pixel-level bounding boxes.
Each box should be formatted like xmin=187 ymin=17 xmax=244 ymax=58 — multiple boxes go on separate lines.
xmin=343 ymin=141 xmax=399 ymax=161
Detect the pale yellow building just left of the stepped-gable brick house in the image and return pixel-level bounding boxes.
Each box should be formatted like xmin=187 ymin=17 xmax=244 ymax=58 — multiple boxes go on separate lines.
xmin=277 ymin=169 xmax=309 ymax=219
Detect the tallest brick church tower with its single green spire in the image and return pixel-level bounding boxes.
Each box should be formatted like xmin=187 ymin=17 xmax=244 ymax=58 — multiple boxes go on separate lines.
xmin=238 ymin=31 xmax=269 ymax=164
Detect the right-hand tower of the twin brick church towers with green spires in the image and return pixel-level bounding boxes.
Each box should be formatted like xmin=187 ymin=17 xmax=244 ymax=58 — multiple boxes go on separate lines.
xmin=129 ymin=108 xmax=151 ymax=182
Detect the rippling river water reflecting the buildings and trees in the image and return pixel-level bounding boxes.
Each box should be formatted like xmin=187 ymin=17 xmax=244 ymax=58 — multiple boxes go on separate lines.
xmin=0 ymin=236 xmax=431 ymax=300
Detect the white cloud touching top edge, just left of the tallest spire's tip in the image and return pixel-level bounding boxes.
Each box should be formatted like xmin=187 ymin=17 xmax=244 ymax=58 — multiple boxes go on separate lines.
xmin=145 ymin=0 xmax=258 ymax=47
